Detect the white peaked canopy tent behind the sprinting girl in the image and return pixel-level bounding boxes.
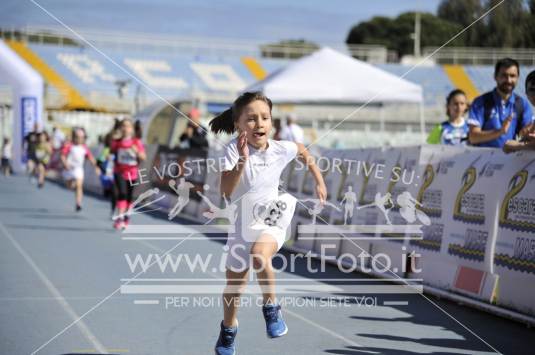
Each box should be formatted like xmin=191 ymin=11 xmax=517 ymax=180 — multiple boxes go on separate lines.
xmin=245 ymin=47 xmax=425 ymax=139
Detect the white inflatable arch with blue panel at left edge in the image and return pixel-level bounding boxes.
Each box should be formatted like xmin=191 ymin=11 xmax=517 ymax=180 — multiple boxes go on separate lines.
xmin=0 ymin=40 xmax=43 ymax=172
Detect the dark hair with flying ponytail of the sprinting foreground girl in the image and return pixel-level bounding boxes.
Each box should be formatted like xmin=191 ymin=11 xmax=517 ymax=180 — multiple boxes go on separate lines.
xmin=210 ymin=92 xmax=273 ymax=134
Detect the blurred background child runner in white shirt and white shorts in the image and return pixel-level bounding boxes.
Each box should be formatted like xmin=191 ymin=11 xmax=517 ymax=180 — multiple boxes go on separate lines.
xmin=61 ymin=128 xmax=100 ymax=212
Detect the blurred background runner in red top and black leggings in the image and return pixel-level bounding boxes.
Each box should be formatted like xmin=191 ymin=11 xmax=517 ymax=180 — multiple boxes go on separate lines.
xmin=111 ymin=118 xmax=146 ymax=230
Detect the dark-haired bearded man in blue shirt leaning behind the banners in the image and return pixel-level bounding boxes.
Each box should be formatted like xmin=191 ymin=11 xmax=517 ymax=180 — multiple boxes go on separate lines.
xmin=468 ymin=58 xmax=533 ymax=148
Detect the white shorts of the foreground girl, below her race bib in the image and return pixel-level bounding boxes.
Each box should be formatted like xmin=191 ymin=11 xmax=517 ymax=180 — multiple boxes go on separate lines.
xmin=224 ymin=226 xmax=288 ymax=272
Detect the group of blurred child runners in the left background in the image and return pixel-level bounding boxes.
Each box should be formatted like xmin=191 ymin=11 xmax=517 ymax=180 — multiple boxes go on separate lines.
xmin=1 ymin=118 xmax=146 ymax=230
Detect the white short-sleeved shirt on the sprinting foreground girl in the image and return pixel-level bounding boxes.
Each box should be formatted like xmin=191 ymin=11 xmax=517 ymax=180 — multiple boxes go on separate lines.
xmin=223 ymin=138 xmax=297 ymax=239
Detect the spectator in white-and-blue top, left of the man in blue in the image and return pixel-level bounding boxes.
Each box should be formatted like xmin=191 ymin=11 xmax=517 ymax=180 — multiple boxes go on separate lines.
xmin=427 ymin=89 xmax=470 ymax=145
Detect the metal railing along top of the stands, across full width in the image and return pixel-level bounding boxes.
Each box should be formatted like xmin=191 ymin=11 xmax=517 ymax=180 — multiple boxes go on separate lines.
xmin=4 ymin=26 xmax=535 ymax=65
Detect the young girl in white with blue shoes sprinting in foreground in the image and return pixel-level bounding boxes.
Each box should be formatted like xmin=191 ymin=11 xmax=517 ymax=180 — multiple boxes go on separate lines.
xmin=210 ymin=92 xmax=327 ymax=355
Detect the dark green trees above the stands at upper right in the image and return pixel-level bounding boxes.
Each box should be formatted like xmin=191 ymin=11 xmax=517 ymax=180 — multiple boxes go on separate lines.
xmin=346 ymin=0 xmax=535 ymax=56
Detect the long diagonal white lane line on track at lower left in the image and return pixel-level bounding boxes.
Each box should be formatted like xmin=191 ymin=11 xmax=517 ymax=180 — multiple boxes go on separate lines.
xmin=0 ymin=222 xmax=108 ymax=355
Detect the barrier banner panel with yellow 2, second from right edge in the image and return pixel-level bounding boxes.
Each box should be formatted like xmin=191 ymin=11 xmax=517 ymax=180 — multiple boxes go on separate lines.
xmin=438 ymin=149 xmax=504 ymax=272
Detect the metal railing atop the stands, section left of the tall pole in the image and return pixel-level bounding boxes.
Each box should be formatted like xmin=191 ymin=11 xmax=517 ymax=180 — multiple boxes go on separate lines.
xmin=1 ymin=27 xmax=395 ymax=63
